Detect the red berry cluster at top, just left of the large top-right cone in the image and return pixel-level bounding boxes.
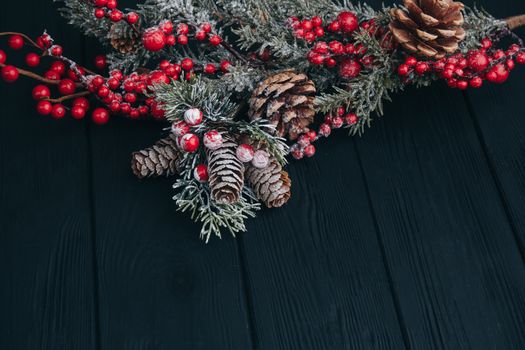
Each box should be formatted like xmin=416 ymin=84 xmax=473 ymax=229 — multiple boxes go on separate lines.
xmin=290 ymin=12 xmax=382 ymax=79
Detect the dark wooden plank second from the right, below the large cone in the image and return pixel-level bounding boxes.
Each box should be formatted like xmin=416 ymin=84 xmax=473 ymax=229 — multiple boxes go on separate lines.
xmin=357 ymin=84 xmax=525 ymax=349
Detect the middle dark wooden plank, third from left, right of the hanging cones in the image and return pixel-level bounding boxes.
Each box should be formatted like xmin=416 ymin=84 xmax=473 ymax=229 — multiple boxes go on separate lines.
xmin=237 ymin=132 xmax=405 ymax=349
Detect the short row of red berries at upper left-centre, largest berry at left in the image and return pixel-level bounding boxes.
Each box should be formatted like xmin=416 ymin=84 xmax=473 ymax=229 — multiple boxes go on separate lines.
xmin=142 ymin=20 xmax=223 ymax=52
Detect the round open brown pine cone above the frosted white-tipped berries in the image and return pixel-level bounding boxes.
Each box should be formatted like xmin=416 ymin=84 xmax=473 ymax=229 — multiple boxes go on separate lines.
xmin=249 ymin=71 xmax=316 ymax=140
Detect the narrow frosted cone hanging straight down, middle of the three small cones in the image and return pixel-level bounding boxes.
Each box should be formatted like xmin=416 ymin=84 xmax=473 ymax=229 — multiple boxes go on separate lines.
xmin=206 ymin=134 xmax=244 ymax=204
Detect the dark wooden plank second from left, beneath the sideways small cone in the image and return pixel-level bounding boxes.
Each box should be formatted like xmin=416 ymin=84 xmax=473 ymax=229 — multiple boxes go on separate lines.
xmin=91 ymin=118 xmax=251 ymax=349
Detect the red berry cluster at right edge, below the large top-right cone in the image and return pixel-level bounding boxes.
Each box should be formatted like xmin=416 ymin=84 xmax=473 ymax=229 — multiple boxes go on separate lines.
xmin=397 ymin=38 xmax=525 ymax=90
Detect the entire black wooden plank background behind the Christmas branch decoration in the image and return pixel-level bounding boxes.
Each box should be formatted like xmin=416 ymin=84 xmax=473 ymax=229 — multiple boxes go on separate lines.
xmin=0 ymin=0 xmax=525 ymax=350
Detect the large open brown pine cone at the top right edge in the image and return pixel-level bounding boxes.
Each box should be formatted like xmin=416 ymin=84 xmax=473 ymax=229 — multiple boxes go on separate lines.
xmin=390 ymin=0 xmax=465 ymax=59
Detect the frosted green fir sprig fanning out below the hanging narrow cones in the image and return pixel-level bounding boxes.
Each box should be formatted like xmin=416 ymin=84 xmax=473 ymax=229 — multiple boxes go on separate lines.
xmin=173 ymin=154 xmax=261 ymax=243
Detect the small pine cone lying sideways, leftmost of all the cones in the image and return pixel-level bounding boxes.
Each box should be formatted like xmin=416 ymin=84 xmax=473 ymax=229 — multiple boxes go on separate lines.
xmin=131 ymin=134 xmax=182 ymax=179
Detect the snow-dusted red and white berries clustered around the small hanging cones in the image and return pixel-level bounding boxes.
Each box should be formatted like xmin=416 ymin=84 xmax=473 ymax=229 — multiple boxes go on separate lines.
xmin=171 ymin=108 xmax=270 ymax=182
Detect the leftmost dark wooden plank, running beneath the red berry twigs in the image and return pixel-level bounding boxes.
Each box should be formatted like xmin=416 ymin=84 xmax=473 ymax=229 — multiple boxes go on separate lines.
xmin=0 ymin=1 xmax=97 ymax=350
